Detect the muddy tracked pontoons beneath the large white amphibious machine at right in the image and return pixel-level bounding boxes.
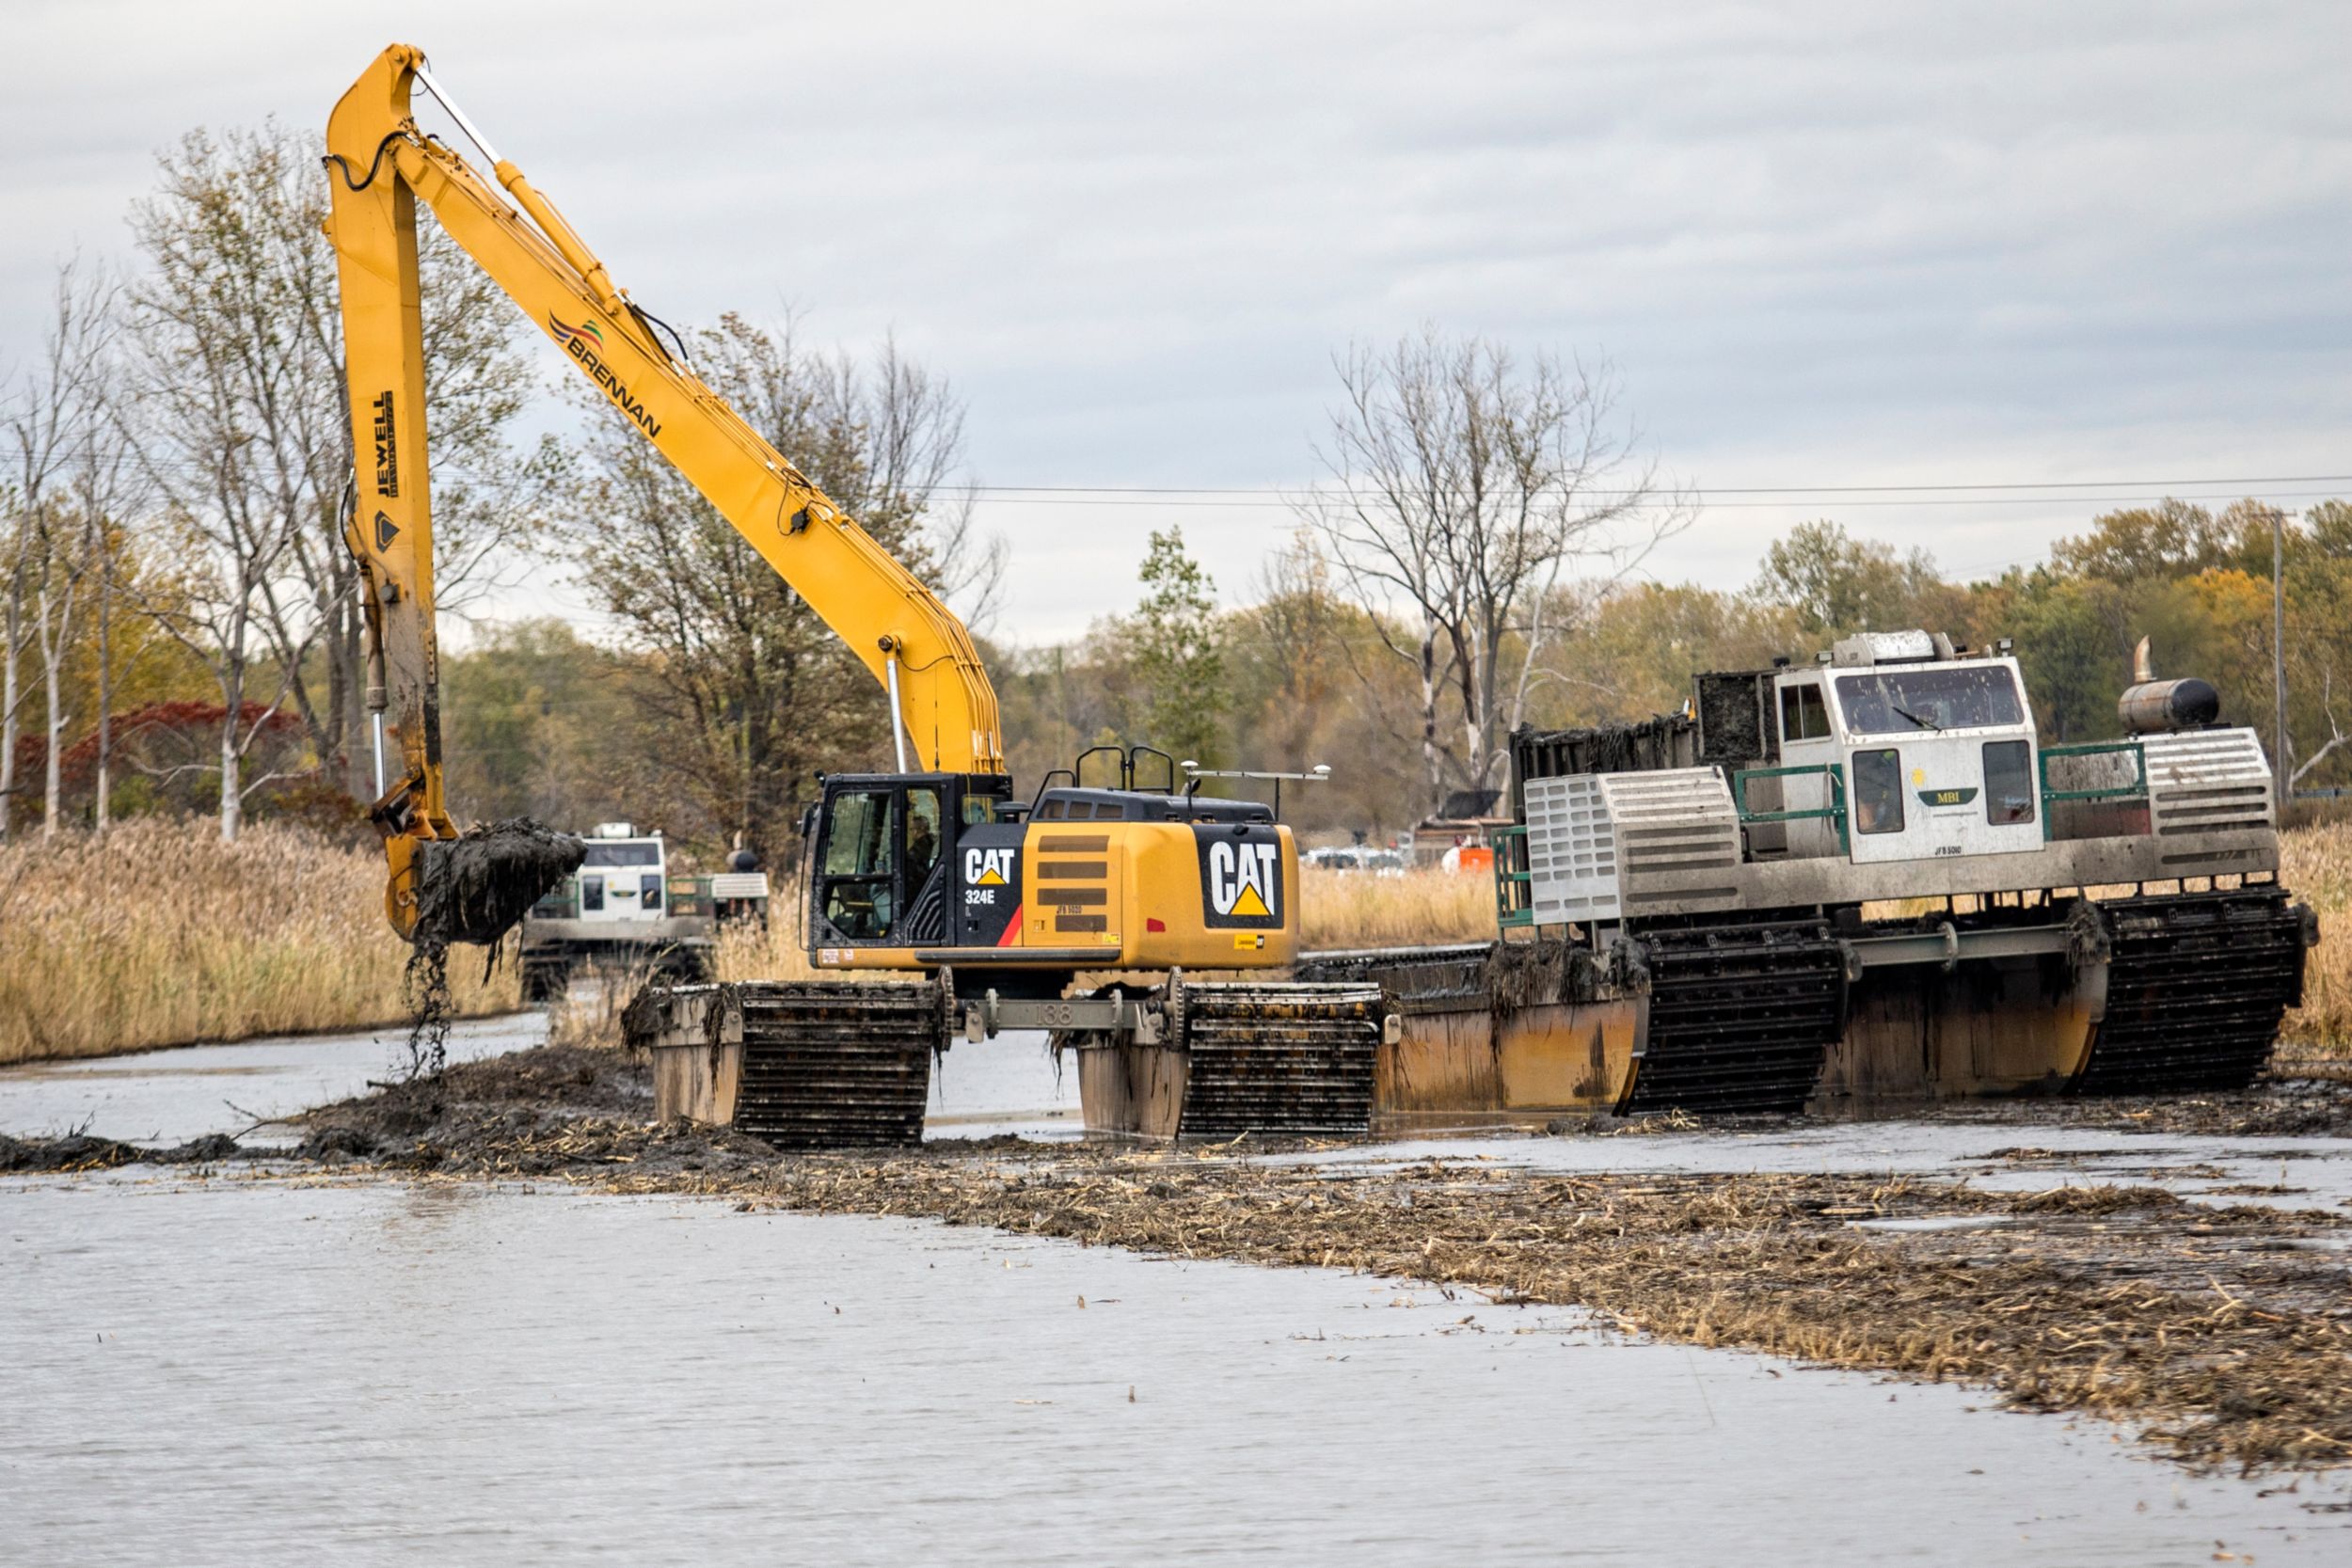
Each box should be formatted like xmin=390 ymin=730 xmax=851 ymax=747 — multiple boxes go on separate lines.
xmin=1301 ymin=884 xmax=2314 ymax=1133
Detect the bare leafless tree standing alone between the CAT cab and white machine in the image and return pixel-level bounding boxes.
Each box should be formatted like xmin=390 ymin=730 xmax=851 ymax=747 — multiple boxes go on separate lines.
xmin=1294 ymin=329 xmax=1687 ymax=809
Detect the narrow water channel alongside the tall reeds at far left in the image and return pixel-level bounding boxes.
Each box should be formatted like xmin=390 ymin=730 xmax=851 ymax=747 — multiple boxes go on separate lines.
xmin=0 ymin=1013 xmax=548 ymax=1145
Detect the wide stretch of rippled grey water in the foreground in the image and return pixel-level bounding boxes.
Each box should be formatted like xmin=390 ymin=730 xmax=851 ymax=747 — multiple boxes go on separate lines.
xmin=0 ymin=1178 xmax=2352 ymax=1568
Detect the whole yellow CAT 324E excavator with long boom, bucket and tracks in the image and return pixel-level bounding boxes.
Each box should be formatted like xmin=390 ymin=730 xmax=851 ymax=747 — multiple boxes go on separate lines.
xmin=325 ymin=44 xmax=1395 ymax=1145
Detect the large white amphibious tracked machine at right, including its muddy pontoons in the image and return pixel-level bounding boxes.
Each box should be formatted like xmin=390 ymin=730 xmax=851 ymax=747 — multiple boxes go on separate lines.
xmin=1301 ymin=630 xmax=2319 ymax=1129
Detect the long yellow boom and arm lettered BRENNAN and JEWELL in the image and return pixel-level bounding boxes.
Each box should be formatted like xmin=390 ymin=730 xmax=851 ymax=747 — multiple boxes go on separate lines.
xmin=327 ymin=44 xmax=1005 ymax=936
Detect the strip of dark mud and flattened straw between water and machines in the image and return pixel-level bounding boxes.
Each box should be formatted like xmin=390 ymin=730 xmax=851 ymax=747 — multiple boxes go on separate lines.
xmin=14 ymin=1049 xmax=2314 ymax=1472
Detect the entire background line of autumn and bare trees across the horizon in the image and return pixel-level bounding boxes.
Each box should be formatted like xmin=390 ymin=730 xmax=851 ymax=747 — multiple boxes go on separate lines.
xmin=0 ymin=127 xmax=2352 ymax=856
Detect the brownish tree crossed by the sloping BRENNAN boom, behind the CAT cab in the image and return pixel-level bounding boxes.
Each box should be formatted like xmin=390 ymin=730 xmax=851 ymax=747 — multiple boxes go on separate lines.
xmin=572 ymin=315 xmax=1002 ymax=851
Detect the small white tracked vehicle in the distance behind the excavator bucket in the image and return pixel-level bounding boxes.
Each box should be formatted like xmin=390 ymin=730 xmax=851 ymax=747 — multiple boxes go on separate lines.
xmin=522 ymin=823 xmax=770 ymax=1002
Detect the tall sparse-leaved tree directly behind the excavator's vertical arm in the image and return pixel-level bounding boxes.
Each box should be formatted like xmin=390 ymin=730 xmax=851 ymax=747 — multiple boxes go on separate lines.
xmin=112 ymin=124 xmax=563 ymax=834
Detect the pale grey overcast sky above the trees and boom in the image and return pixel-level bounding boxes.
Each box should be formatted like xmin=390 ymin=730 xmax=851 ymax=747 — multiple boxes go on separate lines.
xmin=0 ymin=0 xmax=2352 ymax=644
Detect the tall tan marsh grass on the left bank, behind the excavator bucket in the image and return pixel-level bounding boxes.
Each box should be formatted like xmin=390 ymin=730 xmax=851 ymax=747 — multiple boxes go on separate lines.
xmin=0 ymin=818 xmax=517 ymax=1063
